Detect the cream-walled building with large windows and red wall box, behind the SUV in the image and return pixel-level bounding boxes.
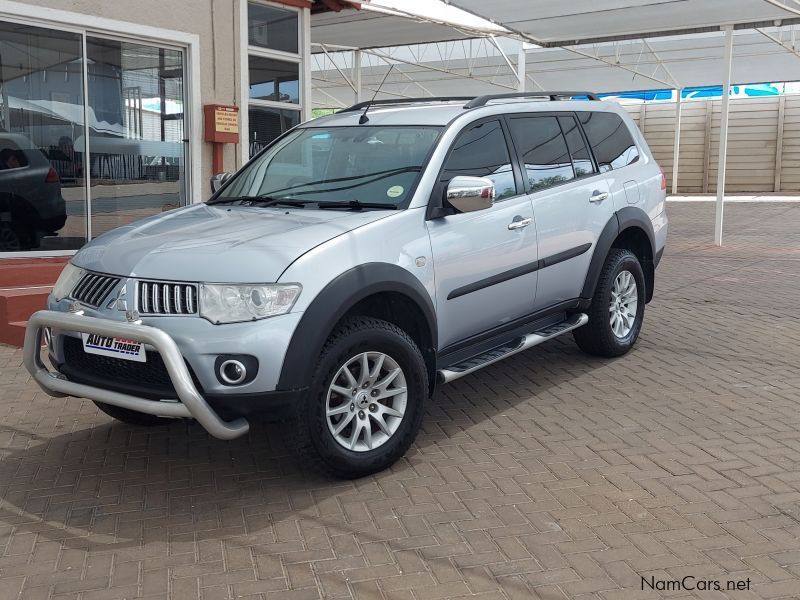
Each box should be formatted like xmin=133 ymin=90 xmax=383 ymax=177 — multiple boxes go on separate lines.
xmin=0 ymin=0 xmax=359 ymax=255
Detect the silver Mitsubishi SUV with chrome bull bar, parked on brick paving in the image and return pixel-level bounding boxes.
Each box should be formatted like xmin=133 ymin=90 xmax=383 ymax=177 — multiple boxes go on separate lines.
xmin=25 ymin=92 xmax=667 ymax=477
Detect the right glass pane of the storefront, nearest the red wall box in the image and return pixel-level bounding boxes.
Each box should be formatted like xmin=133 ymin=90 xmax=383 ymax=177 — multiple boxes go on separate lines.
xmin=86 ymin=36 xmax=186 ymax=237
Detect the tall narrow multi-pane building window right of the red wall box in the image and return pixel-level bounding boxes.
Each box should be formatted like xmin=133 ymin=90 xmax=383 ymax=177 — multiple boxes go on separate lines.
xmin=247 ymin=2 xmax=303 ymax=156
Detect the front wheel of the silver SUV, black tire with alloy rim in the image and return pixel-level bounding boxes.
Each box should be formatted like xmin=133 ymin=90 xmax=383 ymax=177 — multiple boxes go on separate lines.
xmin=293 ymin=317 xmax=428 ymax=478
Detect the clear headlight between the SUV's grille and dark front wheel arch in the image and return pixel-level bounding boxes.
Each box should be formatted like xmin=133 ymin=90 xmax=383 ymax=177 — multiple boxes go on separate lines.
xmin=200 ymin=283 xmax=302 ymax=324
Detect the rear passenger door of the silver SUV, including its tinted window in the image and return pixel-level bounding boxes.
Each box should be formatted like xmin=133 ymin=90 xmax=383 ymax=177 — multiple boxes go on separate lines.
xmin=509 ymin=113 xmax=614 ymax=310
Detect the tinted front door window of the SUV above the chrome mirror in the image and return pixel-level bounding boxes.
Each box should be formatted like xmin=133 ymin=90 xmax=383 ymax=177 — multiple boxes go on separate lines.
xmin=444 ymin=121 xmax=517 ymax=199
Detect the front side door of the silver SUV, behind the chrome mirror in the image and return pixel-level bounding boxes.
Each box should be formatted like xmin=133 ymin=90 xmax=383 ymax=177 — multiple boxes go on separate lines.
xmin=427 ymin=120 xmax=537 ymax=350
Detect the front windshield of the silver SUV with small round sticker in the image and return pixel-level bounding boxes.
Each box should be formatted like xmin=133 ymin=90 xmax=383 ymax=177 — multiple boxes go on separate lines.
xmin=212 ymin=126 xmax=441 ymax=208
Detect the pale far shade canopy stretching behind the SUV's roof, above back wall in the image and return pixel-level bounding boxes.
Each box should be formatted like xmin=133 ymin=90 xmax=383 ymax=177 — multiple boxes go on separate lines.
xmin=312 ymin=27 xmax=800 ymax=107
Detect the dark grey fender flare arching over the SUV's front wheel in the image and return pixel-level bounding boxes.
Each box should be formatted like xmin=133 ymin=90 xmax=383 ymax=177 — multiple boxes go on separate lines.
xmin=277 ymin=263 xmax=438 ymax=390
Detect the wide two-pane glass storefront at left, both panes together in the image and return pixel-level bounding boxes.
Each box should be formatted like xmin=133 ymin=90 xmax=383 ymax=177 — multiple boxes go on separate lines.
xmin=0 ymin=21 xmax=188 ymax=253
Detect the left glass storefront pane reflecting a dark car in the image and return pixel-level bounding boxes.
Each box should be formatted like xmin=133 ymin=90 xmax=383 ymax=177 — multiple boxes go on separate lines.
xmin=0 ymin=22 xmax=87 ymax=253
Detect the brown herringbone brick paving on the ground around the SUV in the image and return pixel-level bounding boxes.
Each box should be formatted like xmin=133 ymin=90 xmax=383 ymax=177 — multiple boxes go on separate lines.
xmin=0 ymin=203 xmax=800 ymax=600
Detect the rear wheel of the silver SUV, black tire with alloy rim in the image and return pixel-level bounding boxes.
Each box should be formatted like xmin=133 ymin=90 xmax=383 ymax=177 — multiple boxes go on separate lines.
xmin=572 ymin=248 xmax=645 ymax=357
